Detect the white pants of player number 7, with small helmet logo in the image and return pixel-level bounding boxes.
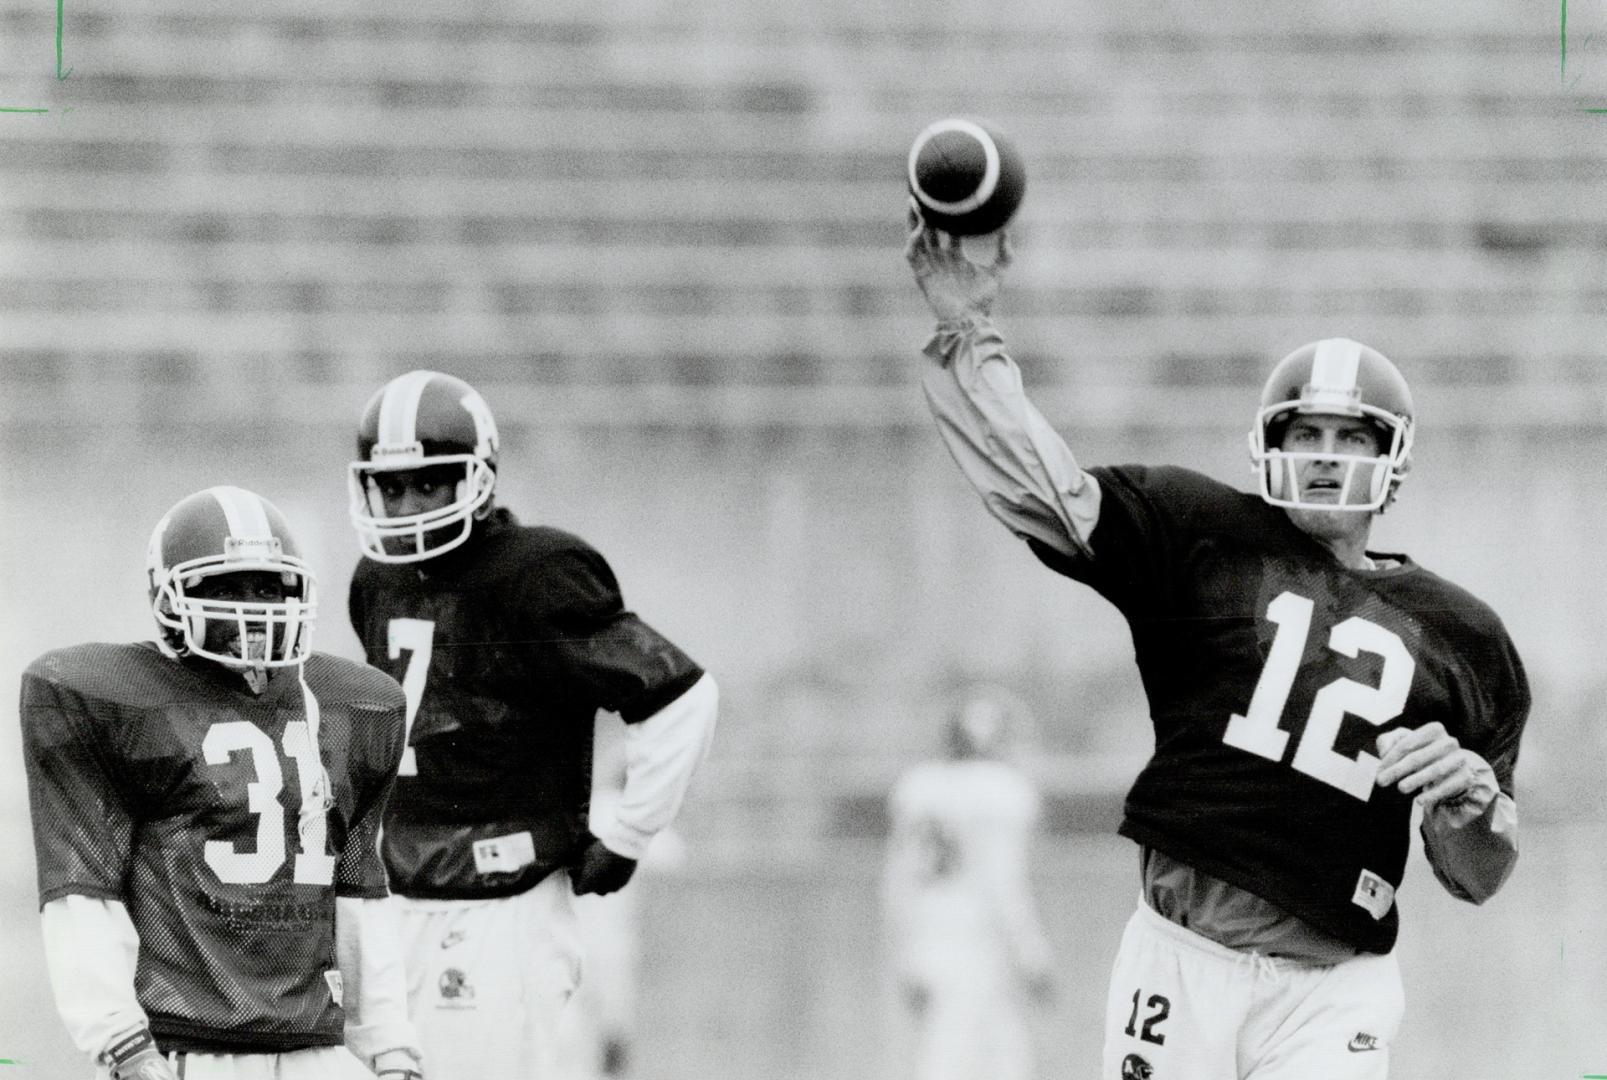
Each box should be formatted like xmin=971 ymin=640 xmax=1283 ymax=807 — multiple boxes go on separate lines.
xmin=399 ymin=869 xmax=580 ymax=1080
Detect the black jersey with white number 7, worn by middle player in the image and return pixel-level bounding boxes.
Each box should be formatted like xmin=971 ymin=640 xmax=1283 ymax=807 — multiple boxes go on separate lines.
xmin=350 ymin=509 xmax=702 ymax=898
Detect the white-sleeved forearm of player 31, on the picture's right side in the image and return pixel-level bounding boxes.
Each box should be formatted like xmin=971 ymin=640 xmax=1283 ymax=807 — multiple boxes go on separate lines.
xmin=334 ymin=897 xmax=424 ymax=1080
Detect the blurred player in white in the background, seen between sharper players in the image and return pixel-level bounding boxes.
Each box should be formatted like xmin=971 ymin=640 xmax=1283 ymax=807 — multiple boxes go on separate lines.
xmin=882 ymin=688 xmax=1054 ymax=1080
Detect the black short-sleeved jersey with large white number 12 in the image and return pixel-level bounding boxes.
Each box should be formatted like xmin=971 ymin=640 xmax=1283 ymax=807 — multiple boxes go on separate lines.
xmin=1032 ymin=466 xmax=1528 ymax=953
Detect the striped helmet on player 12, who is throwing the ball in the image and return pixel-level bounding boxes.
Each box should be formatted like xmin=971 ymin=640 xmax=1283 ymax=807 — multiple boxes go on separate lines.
xmin=1250 ymin=338 xmax=1416 ymax=513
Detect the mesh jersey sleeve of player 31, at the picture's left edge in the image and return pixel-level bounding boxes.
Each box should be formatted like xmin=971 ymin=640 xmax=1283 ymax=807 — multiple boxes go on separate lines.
xmin=21 ymin=670 xmax=135 ymax=906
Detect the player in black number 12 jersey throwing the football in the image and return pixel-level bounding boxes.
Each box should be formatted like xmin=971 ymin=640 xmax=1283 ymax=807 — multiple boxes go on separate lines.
xmin=906 ymin=222 xmax=1530 ymax=1080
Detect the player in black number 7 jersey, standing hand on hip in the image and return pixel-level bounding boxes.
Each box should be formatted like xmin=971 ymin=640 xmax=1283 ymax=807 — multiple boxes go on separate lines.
xmin=349 ymin=371 xmax=717 ymax=1080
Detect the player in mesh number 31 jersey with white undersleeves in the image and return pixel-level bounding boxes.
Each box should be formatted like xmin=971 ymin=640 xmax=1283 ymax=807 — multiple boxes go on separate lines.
xmin=21 ymin=487 xmax=419 ymax=1080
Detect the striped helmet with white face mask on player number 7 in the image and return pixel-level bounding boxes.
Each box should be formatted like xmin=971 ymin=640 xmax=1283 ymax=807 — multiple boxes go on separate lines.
xmin=347 ymin=371 xmax=497 ymax=563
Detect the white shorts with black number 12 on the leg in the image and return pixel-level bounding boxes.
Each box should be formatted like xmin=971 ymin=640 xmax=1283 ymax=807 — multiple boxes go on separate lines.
xmin=1101 ymin=902 xmax=1405 ymax=1080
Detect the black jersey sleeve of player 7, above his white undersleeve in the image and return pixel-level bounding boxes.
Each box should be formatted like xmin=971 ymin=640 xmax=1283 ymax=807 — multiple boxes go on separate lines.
xmin=532 ymin=543 xmax=704 ymax=723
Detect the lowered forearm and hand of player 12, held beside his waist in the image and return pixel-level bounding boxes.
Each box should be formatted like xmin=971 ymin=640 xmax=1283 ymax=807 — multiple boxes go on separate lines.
xmin=1377 ymin=723 xmax=1517 ymax=903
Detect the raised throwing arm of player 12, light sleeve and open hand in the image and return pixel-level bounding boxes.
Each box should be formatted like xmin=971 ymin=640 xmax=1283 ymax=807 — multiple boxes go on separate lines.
xmin=905 ymin=219 xmax=1099 ymax=558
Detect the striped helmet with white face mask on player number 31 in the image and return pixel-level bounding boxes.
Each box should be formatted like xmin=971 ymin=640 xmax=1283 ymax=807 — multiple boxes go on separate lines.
xmin=146 ymin=487 xmax=318 ymax=669
